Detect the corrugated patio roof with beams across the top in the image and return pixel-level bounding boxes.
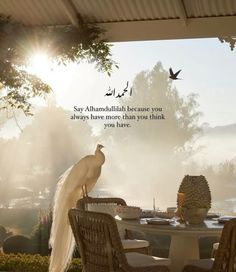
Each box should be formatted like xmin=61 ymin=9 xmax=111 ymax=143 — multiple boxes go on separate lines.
xmin=0 ymin=0 xmax=236 ymax=42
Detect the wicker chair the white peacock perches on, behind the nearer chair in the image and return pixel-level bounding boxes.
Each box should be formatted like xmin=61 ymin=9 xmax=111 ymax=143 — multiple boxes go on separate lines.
xmin=76 ymin=197 xmax=151 ymax=254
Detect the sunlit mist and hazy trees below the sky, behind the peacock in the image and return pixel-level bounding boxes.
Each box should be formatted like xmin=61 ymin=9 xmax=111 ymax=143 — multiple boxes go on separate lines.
xmin=0 ymin=62 xmax=236 ymax=215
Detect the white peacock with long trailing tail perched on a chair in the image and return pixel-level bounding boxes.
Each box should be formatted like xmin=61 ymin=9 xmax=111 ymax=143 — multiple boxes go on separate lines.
xmin=49 ymin=145 xmax=105 ymax=272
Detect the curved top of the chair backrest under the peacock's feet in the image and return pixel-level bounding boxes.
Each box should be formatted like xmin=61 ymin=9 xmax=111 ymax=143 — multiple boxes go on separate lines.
xmin=76 ymin=197 xmax=127 ymax=210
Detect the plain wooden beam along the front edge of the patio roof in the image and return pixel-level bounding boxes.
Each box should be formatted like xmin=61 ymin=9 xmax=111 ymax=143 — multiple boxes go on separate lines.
xmin=97 ymin=16 xmax=236 ymax=42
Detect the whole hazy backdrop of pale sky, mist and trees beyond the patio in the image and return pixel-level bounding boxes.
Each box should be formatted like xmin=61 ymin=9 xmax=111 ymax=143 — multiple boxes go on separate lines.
xmin=0 ymin=39 xmax=236 ymax=213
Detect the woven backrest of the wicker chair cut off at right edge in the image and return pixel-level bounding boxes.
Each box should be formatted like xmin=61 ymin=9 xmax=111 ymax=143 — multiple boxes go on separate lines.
xmin=212 ymin=219 xmax=236 ymax=272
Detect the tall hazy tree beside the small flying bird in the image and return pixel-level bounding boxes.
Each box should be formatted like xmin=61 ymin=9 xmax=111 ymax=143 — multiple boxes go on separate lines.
xmin=104 ymin=62 xmax=201 ymax=156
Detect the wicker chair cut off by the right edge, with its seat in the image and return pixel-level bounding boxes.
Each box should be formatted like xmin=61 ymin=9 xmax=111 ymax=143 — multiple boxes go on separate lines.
xmin=183 ymin=219 xmax=236 ymax=272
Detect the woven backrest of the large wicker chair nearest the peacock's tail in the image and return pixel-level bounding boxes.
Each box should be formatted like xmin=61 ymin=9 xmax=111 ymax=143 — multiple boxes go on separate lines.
xmin=69 ymin=209 xmax=128 ymax=272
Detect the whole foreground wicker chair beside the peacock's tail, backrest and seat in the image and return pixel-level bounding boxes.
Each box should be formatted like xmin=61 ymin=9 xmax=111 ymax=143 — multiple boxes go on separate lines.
xmin=69 ymin=209 xmax=169 ymax=272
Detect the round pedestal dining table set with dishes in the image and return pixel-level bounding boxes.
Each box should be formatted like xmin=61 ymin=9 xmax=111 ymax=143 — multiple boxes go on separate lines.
xmin=116 ymin=217 xmax=223 ymax=272
